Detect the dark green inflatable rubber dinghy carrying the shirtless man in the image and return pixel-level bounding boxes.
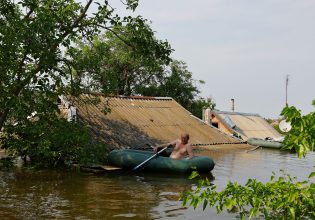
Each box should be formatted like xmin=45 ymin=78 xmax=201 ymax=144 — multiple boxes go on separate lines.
xmin=108 ymin=149 xmax=214 ymax=173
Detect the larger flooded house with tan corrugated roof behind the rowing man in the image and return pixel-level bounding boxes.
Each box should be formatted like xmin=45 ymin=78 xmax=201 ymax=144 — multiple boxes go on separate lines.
xmin=59 ymin=93 xmax=243 ymax=149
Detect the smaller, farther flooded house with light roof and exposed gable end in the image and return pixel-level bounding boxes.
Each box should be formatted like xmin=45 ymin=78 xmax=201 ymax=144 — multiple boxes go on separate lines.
xmin=210 ymin=110 xmax=282 ymax=141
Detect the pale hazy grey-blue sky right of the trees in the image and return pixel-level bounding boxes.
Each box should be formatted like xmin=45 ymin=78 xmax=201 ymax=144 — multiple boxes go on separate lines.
xmin=110 ymin=0 xmax=315 ymax=118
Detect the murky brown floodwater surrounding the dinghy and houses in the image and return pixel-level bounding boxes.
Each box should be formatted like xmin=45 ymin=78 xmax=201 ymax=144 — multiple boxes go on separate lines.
xmin=0 ymin=149 xmax=315 ymax=219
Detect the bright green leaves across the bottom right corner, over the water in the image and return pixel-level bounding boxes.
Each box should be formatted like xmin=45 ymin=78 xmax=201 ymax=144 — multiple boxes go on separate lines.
xmin=181 ymin=173 xmax=315 ymax=219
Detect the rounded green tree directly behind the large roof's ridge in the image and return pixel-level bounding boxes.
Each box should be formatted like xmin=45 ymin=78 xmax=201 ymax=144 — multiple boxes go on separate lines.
xmin=68 ymin=22 xmax=172 ymax=95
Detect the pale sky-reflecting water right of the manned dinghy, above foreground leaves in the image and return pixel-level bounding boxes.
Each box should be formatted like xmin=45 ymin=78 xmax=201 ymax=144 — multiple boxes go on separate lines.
xmin=208 ymin=149 xmax=315 ymax=186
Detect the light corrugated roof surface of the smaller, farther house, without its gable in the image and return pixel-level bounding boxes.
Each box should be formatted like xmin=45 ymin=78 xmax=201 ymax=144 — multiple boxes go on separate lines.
xmin=214 ymin=111 xmax=281 ymax=140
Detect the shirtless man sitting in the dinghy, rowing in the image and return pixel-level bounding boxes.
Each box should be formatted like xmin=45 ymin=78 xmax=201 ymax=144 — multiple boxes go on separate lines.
xmin=154 ymin=133 xmax=194 ymax=160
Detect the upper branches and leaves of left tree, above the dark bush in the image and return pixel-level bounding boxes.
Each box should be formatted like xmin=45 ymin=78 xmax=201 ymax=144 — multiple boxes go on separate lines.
xmin=0 ymin=0 xmax=173 ymax=130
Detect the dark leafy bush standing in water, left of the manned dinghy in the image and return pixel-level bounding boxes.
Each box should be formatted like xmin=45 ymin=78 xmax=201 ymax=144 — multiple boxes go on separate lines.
xmin=1 ymin=116 xmax=107 ymax=167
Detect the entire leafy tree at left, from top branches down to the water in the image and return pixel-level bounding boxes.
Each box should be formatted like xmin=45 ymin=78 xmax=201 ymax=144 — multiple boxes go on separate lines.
xmin=0 ymin=0 xmax=175 ymax=165
